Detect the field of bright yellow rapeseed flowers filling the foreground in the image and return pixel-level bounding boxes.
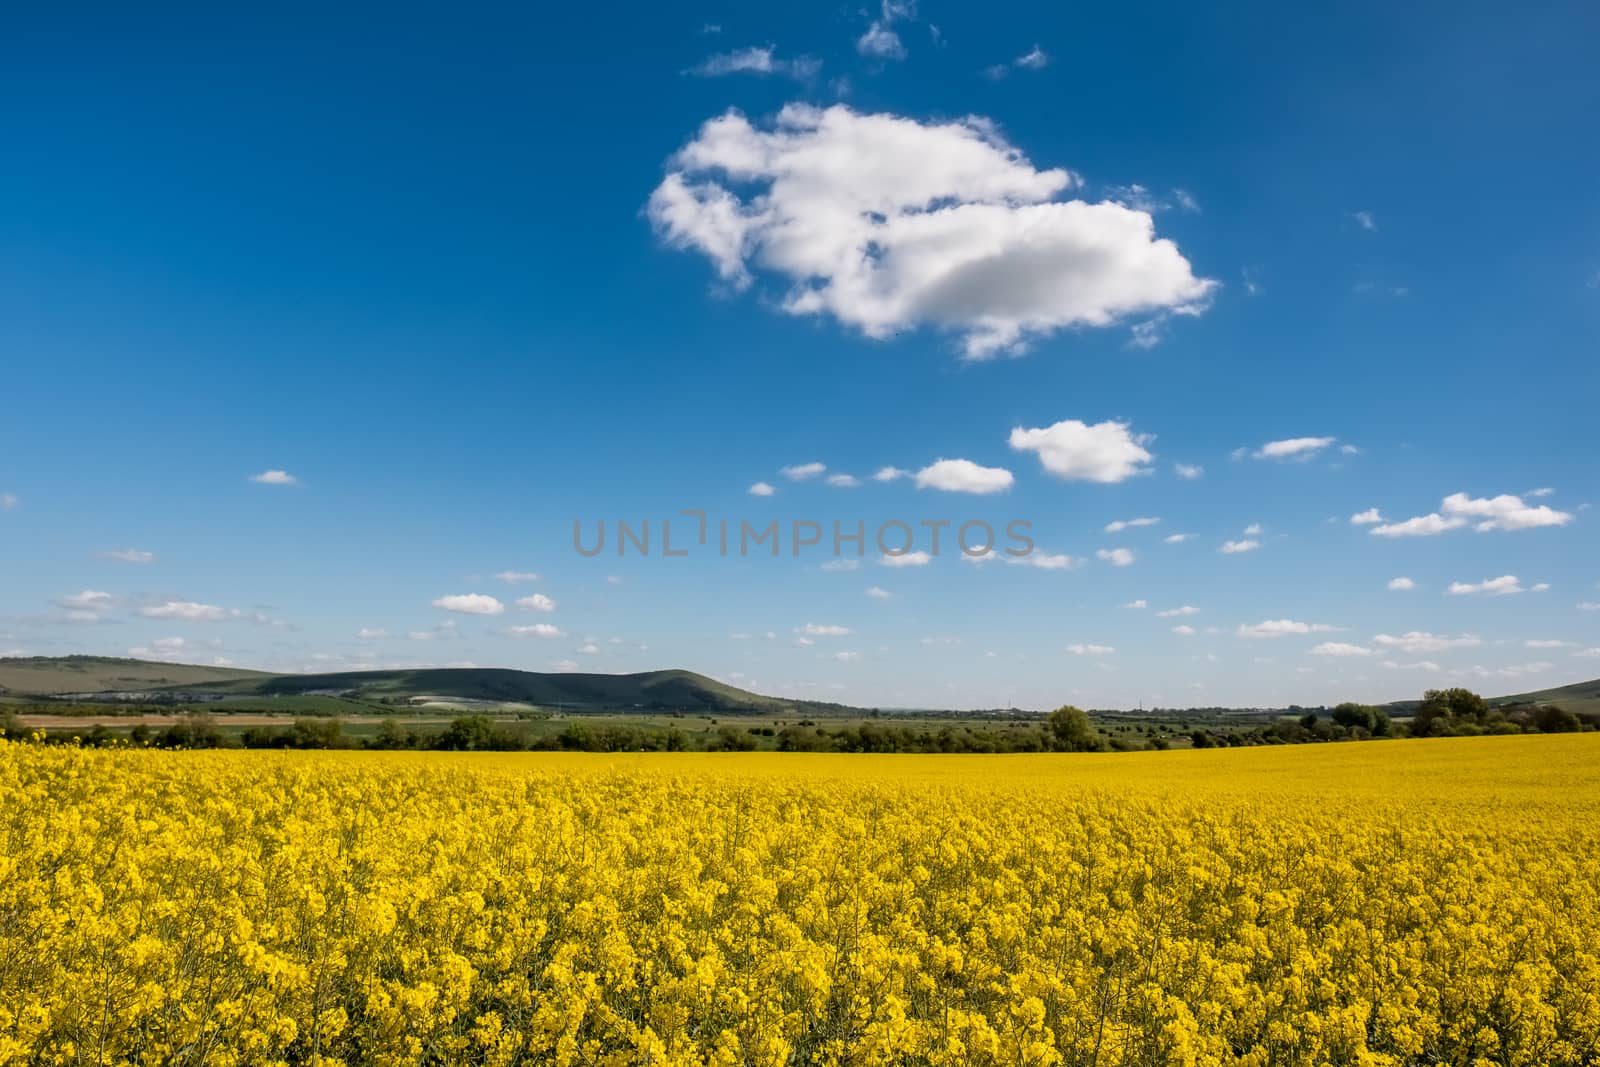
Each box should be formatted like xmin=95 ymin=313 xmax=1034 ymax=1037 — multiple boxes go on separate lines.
xmin=0 ymin=734 xmax=1600 ymax=1065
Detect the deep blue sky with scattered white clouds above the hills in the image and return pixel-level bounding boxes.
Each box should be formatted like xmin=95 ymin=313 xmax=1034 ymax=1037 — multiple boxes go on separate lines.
xmin=0 ymin=3 xmax=1600 ymax=707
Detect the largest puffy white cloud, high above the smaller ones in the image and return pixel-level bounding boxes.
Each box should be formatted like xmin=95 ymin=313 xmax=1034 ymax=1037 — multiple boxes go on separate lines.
xmin=648 ymin=104 xmax=1216 ymax=358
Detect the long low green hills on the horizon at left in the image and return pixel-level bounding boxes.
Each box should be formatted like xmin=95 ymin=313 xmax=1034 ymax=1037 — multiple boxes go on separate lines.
xmin=0 ymin=656 xmax=853 ymax=712
